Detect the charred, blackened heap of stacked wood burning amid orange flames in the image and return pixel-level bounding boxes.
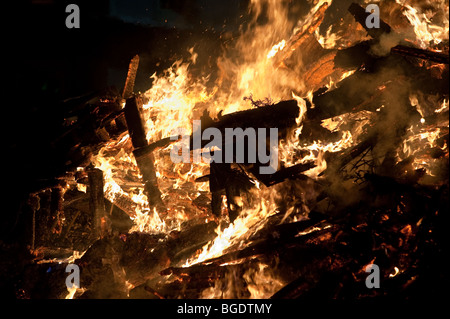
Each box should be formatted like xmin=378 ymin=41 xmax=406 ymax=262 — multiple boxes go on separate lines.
xmin=12 ymin=4 xmax=449 ymax=299
